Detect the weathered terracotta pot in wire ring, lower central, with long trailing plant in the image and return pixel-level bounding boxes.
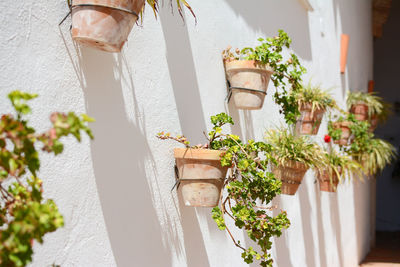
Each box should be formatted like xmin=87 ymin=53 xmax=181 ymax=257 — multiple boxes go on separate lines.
xmin=174 ymin=148 xmax=229 ymax=207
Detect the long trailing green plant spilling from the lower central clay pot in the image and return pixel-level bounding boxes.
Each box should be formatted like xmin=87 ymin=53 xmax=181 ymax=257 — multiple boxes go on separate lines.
xmin=157 ymin=113 xmax=290 ymax=266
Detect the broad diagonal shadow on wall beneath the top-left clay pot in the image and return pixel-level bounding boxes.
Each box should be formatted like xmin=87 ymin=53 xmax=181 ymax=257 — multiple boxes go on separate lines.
xmin=72 ymin=48 xmax=171 ymax=266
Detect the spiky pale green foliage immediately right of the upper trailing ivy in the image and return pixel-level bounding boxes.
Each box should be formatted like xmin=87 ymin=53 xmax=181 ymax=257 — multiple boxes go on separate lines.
xmin=291 ymin=82 xmax=339 ymax=111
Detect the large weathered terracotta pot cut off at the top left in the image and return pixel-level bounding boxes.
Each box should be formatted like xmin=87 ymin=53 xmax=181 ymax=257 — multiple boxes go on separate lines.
xmin=71 ymin=0 xmax=145 ymax=52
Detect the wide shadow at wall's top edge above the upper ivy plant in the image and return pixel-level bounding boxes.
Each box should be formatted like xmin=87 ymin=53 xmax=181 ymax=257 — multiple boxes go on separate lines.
xmin=226 ymin=0 xmax=312 ymax=60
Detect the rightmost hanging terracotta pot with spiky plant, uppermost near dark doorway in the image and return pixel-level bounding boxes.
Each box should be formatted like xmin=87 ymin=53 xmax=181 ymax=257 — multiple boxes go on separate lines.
xmin=347 ymin=92 xmax=391 ymax=131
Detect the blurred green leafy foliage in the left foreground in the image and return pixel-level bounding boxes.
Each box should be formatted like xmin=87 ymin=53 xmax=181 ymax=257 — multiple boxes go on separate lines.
xmin=0 ymin=91 xmax=93 ymax=266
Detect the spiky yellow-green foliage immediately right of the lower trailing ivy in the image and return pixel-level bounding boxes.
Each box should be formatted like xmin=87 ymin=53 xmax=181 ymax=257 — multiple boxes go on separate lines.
xmin=265 ymin=128 xmax=324 ymax=170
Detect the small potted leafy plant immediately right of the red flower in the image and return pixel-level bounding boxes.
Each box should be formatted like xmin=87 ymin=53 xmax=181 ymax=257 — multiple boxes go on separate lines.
xmin=328 ymin=114 xmax=354 ymax=146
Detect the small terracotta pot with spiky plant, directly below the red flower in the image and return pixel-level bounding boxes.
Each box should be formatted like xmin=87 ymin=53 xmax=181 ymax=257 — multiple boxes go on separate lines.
xmin=317 ymin=147 xmax=361 ymax=192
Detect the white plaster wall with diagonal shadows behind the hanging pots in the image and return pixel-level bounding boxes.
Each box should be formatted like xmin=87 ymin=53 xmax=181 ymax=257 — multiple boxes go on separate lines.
xmin=0 ymin=0 xmax=372 ymax=267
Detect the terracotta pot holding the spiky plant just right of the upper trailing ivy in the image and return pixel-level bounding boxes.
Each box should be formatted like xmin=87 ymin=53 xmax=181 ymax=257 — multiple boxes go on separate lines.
xmin=296 ymin=103 xmax=325 ymax=135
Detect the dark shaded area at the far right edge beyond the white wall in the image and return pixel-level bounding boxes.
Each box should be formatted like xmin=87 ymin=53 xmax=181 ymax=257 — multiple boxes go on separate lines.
xmin=374 ymin=1 xmax=400 ymax=231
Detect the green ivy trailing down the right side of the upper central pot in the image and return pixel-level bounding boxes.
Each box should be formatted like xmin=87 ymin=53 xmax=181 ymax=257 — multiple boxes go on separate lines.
xmin=222 ymin=30 xmax=306 ymax=124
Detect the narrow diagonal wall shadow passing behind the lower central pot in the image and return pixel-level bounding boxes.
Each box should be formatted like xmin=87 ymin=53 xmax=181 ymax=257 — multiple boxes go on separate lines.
xmin=160 ymin=8 xmax=218 ymax=267
